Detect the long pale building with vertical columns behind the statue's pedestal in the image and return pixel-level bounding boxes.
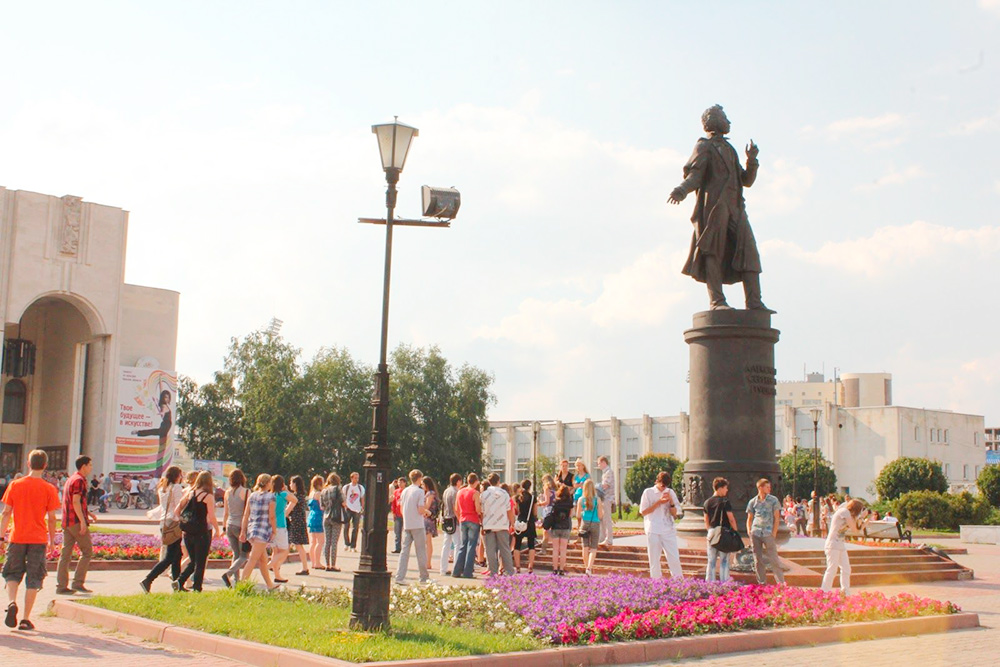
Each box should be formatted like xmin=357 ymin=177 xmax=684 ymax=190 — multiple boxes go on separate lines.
xmin=483 ymin=373 xmax=986 ymax=499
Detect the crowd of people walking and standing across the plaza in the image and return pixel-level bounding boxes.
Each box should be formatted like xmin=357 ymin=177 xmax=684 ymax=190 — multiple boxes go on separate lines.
xmin=0 ymin=450 xmax=869 ymax=629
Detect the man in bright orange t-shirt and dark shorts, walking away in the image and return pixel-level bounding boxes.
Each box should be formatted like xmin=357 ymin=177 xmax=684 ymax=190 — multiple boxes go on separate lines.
xmin=0 ymin=449 xmax=59 ymax=630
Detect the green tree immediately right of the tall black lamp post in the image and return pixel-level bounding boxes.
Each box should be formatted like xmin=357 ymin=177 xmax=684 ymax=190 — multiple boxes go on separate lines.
xmin=389 ymin=345 xmax=496 ymax=481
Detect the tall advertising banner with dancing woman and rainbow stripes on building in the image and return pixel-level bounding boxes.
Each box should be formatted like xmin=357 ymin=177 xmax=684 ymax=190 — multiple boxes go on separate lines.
xmin=115 ymin=366 xmax=177 ymax=477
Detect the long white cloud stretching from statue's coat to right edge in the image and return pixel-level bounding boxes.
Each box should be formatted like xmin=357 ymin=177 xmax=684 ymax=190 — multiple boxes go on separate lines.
xmin=761 ymin=221 xmax=1000 ymax=278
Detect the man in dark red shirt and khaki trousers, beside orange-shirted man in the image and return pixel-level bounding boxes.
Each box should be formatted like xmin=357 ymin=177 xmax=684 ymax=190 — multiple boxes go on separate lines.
xmin=56 ymin=456 xmax=97 ymax=595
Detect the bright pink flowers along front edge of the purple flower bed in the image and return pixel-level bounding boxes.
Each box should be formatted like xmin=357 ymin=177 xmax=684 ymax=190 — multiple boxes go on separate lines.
xmin=557 ymin=585 xmax=960 ymax=644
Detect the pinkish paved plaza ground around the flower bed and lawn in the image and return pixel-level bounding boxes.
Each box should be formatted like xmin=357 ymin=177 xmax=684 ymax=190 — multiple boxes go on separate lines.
xmin=0 ymin=538 xmax=1000 ymax=667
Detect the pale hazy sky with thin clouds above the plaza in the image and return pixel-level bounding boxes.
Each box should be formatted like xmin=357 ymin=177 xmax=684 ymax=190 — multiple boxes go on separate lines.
xmin=0 ymin=0 xmax=1000 ymax=426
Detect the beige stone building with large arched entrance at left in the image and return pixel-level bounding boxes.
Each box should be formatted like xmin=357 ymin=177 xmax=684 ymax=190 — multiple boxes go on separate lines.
xmin=0 ymin=187 xmax=179 ymax=480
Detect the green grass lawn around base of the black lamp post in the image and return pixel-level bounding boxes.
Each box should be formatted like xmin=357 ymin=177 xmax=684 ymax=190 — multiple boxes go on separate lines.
xmin=85 ymin=587 xmax=544 ymax=662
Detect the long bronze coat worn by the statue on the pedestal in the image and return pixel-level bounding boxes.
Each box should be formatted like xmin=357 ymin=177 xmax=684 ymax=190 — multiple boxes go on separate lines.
xmin=678 ymin=137 xmax=760 ymax=285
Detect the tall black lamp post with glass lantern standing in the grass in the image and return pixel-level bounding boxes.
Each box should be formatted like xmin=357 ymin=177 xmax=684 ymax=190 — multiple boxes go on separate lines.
xmin=350 ymin=120 xmax=417 ymax=631
